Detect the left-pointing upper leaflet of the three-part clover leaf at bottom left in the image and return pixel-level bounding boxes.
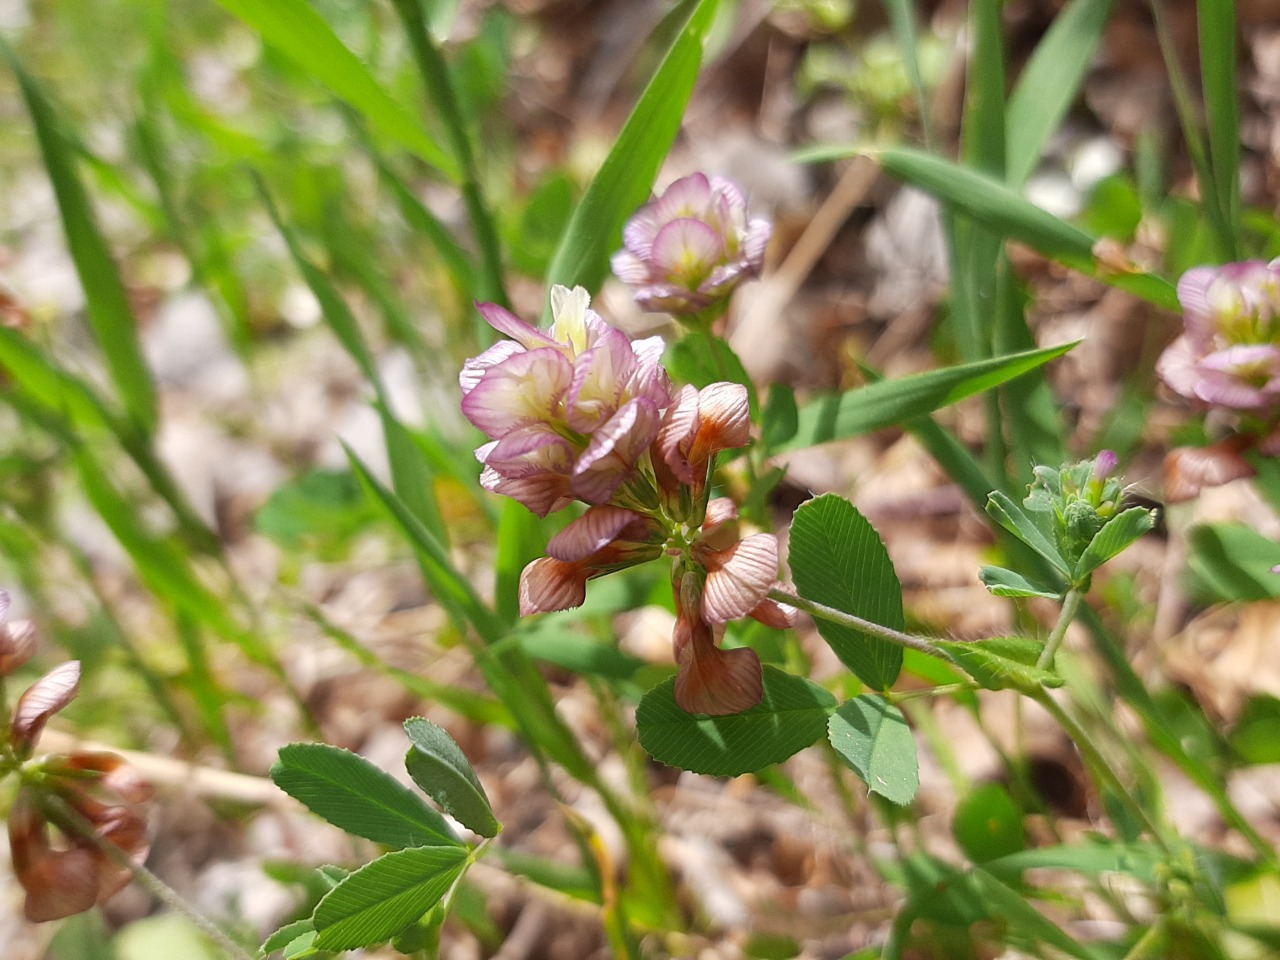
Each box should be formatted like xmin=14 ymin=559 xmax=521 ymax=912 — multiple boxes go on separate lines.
xmin=271 ymin=744 xmax=458 ymax=847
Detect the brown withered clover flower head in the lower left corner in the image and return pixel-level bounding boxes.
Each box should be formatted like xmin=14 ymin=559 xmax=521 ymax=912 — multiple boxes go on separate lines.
xmin=9 ymin=660 xmax=151 ymax=922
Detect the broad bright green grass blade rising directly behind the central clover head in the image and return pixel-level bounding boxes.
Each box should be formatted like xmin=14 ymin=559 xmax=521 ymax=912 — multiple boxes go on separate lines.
xmin=547 ymin=0 xmax=718 ymax=291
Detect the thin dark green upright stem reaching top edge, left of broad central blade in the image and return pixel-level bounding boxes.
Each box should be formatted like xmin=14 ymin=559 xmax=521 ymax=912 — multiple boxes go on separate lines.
xmin=394 ymin=0 xmax=509 ymax=306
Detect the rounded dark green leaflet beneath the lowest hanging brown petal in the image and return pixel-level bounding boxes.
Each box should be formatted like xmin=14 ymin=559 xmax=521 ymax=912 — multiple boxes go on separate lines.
xmin=636 ymin=666 xmax=836 ymax=777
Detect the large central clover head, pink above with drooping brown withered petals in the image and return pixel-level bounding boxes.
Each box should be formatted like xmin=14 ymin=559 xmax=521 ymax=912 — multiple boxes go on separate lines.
xmin=460 ymin=289 xmax=796 ymax=716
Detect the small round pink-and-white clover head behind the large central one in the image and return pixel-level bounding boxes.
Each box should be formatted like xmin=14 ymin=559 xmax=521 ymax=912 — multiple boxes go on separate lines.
xmin=613 ymin=173 xmax=773 ymax=317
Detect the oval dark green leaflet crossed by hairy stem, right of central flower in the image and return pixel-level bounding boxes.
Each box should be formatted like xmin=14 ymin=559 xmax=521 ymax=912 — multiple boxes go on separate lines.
xmin=790 ymin=493 xmax=904 ymax=690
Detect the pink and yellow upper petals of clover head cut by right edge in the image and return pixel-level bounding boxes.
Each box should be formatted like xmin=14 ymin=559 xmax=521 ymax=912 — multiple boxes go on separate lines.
xmin=1156 ymin=260 xmax=1280 ymax=419
